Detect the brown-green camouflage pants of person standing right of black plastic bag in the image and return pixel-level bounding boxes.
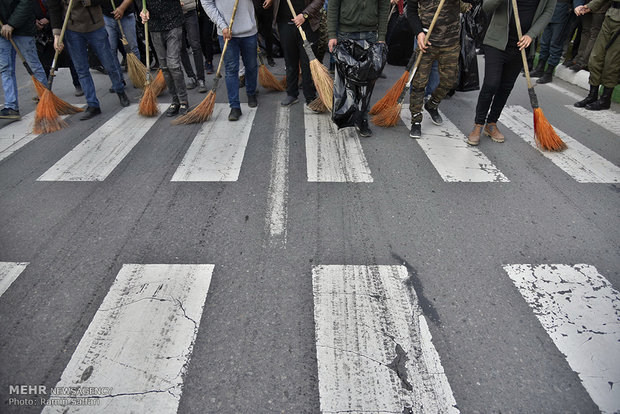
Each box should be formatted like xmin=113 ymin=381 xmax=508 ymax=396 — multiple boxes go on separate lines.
xmin=409 ymin=43 xmax=461 ymax=122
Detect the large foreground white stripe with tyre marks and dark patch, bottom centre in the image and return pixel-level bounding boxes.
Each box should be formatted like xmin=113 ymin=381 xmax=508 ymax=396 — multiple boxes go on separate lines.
xmin=312 ymin=265 xmax=459 ymax=414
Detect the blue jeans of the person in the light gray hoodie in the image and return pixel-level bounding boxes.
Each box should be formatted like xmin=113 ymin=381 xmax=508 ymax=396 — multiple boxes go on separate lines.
xmin=218 ymin=35 xmax=258 ymax=108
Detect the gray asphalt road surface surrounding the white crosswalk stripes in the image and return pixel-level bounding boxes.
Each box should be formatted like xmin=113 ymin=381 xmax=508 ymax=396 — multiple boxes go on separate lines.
xmin=0 ymin=52 xmax=620 ymax=413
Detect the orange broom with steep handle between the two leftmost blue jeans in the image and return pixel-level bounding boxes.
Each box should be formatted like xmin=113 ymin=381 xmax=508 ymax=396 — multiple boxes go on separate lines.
xmin=32 ymin=0 xmax=83 ymax=134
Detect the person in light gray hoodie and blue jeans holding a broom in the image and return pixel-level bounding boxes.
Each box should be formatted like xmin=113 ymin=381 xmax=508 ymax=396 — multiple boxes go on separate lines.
xmin=202 ymin=0 xmax=258 ymax=121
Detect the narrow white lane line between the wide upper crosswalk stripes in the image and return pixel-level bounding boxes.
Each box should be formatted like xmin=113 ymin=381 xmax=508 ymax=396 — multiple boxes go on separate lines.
xmin=267 ymin=108 xmax=290 ymax=242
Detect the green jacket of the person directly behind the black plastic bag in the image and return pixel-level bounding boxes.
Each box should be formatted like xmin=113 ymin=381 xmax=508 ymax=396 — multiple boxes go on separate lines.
xmin=327 ymin=0 xmax=390 ymax=41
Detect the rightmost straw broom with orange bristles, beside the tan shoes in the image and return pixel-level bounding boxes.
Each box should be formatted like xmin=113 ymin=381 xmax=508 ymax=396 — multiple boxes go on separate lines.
xmin=512 ymin=0 xmax=566 ymax=151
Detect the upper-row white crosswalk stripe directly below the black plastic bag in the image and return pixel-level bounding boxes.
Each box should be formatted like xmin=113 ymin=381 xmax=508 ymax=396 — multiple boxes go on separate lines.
xmin=304 ymin=107 xmax=373 ymax=183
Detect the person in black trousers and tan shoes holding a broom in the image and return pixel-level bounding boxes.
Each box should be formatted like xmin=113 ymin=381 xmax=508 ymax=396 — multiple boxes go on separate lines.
xmin=467 ymin=0 xmax=556 ymax=145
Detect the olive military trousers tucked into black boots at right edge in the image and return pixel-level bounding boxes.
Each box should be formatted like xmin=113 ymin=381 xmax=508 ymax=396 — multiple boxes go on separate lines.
xmin=588 ymin=17 xmax=620 ymax=88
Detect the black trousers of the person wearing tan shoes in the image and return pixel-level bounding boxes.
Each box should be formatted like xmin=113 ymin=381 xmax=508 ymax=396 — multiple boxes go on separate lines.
xmin=475 ymin=45 xmax=523 ymax=125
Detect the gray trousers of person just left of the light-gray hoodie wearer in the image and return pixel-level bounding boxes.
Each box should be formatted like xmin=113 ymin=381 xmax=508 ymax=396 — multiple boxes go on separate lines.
xmin=151 ymin=27 xmax=188 ymax=103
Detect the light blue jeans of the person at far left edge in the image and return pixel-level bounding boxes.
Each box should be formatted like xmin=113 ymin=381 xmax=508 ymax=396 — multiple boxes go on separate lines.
xmin=0 ymin=36 xmax=47 ymax=111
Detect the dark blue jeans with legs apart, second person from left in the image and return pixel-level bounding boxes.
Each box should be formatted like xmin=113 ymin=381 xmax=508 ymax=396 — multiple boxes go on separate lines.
xmin=64 ymin=27 xmax=125 ymax=108
